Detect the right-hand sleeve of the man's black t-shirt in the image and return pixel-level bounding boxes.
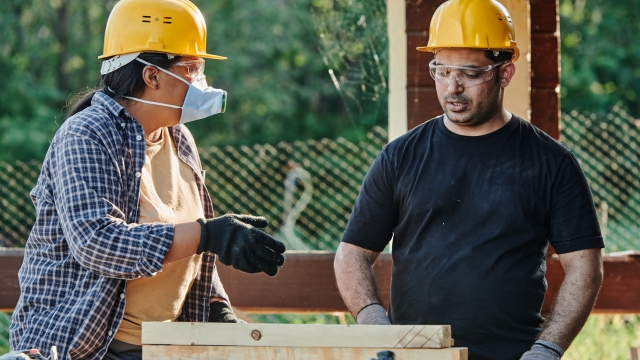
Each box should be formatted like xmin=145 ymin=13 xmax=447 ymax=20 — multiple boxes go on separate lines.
xmin=548 ymin=153 xmax=604 ymax=254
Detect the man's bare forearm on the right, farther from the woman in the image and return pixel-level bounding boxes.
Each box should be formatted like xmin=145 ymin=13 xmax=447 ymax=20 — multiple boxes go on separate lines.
xmin=539 ymin=249 xmax=603 ymax=350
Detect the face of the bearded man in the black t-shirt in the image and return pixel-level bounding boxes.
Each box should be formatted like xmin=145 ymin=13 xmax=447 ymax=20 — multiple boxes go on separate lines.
xmin=435 ymin=49 xmax=502 ymax=127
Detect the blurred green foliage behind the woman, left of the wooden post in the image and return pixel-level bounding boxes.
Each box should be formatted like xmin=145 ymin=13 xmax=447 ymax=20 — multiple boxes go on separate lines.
xmin=0 ymin=0 xmax=387 ymax=161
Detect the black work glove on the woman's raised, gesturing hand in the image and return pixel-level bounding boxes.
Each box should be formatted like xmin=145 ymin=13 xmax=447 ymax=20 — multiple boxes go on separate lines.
xmin=197 ymin=214 xmax=285 ymax=276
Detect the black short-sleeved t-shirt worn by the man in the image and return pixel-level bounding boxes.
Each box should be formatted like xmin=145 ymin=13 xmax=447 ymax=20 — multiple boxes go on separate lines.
xmin=342 ymin=116 xmax=604 ymax=360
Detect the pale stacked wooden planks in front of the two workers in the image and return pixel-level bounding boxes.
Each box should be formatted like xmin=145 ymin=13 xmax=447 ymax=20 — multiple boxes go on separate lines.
xmin=142 ymin=322 xmax=467 ymax=360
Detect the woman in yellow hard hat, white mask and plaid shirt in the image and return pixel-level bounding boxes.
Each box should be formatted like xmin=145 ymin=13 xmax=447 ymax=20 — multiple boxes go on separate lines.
xmin=10 ymin=0 xmax=285 ymax=359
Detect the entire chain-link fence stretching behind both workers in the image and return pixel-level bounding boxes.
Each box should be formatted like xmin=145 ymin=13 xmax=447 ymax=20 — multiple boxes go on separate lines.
xmin=0 ymin=116 xmax=640 ymax=252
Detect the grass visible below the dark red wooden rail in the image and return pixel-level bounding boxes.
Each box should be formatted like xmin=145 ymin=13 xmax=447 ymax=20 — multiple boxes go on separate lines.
xmin=0 ymin=312 xmax=640 ymax=360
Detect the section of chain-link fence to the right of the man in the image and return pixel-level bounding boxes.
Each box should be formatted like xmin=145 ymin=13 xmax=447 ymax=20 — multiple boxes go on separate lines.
xmin=561 ymin=107 xmax=640 ymax=252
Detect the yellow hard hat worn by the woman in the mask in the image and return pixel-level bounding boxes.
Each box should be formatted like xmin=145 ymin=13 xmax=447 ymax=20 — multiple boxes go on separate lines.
xmin=98 ymin=0 xmax=226 ymax=60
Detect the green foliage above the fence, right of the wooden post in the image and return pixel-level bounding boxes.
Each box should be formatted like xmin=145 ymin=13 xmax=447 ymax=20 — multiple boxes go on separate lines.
xmin=560 ymin=0 xmax=640 ymax=117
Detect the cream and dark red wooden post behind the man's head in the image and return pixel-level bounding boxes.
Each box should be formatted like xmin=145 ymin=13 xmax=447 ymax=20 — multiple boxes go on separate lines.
xmin=387 ymin=0 xmax=560 ymax=140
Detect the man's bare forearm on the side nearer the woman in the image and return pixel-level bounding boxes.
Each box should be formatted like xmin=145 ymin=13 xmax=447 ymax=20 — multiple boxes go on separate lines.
xmin=333 ymin=242 xmax=389 ymax=324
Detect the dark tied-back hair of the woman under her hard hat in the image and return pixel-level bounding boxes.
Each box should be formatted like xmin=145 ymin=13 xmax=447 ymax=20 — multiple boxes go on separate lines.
xmin=65 ymin=53 xmax=180 ymax=120
